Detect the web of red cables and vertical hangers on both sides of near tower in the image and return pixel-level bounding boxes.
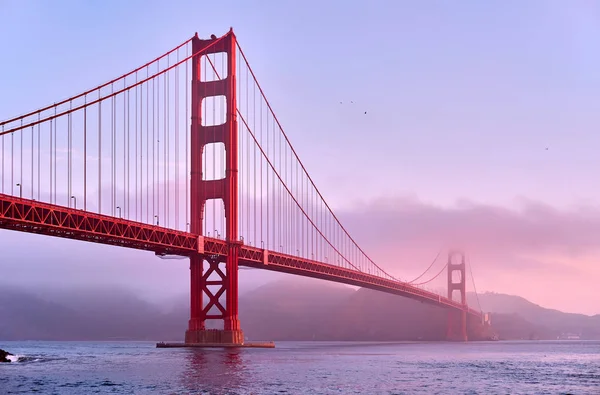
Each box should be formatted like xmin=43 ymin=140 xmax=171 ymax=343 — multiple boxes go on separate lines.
xmin=0 ymin=32 xmax=482 ymax=310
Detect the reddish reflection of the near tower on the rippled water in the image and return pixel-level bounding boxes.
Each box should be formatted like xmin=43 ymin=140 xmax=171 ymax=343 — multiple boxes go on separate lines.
xmin=180 ymin=349 xmax=249 ymax=394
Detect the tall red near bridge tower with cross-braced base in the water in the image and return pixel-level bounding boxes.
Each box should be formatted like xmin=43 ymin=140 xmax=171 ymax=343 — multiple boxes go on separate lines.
xmin=185 ymin=30 xmax=244 ymax=344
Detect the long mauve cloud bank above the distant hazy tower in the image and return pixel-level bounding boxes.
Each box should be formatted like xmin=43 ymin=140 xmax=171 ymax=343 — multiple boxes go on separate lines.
xmin=342 ymin=198 xmax=600 ymax=257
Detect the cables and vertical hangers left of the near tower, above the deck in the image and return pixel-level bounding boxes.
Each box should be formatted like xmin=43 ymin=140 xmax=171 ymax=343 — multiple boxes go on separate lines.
xmin=0 ymin=40 xmax=202 ymax=230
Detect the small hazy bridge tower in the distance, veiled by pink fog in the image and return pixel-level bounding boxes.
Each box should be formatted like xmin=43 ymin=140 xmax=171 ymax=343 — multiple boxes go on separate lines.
xmin=446 ymin=251 xmax=468 ymax=341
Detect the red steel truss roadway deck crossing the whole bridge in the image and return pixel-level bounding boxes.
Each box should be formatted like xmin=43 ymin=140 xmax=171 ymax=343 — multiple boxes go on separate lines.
xmin=0 ymin=194 xmax=481 ymax=319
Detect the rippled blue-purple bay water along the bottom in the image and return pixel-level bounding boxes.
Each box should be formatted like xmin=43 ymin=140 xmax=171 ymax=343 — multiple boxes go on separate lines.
xmin=0 ymin=341 xmax=600 ymax=395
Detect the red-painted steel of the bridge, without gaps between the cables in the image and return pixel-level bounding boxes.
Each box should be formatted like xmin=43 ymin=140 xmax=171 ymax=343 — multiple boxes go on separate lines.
xmin=0 ymin=30 xmax=481 ymax=343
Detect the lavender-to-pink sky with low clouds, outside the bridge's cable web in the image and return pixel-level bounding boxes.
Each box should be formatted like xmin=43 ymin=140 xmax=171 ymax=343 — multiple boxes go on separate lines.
xmin=0 ymin=0 xmax=600 ymax=314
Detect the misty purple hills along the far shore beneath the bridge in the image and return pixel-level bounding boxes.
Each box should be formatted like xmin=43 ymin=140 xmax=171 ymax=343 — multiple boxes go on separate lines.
xmin=0 ymin=280 xmax=600 ymax=341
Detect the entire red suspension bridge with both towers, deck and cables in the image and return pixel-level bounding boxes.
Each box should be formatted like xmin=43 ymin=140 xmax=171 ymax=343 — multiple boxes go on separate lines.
xmin=0 ymin=31 xmax=482 ymax=344
